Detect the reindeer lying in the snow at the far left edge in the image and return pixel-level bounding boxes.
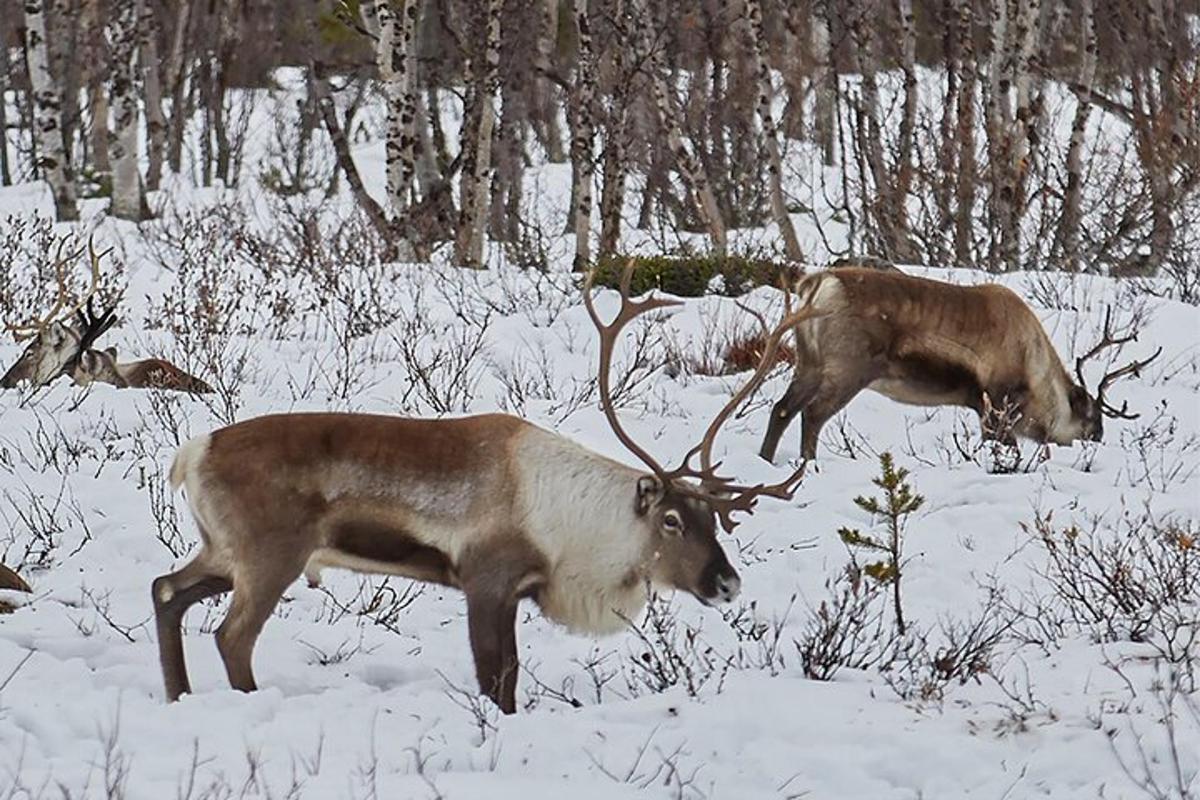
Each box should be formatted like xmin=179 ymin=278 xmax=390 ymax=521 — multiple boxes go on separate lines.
xmin=0 ymin=239 xmax=212 ymax=393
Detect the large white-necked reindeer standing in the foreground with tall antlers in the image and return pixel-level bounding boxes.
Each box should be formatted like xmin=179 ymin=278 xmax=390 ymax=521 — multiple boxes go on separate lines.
xmin=151 ymin=263 xmax=814 ymax=714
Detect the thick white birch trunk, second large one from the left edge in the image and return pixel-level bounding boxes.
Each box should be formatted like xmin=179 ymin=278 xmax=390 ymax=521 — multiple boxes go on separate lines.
xmin=108 ymin=0 xmax=150 ymax=222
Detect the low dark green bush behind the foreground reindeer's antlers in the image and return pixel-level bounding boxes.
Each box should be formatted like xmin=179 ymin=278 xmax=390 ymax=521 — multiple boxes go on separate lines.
xmin=595 ymin=255 xmax=800 ymax=297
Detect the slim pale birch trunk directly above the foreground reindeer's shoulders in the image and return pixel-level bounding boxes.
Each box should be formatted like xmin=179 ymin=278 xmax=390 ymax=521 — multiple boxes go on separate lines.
xmin=455 ymin=0 xmax=504 ymax=269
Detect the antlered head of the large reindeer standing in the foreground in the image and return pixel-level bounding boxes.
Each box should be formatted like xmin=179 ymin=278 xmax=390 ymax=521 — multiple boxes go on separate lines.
xmin=583 ymin=263 xmax=820 ymax=603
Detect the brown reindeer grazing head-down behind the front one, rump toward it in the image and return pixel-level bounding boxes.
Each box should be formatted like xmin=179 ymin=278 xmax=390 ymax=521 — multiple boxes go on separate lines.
xmin=760 ymin=266 xmax=1162 ymax=461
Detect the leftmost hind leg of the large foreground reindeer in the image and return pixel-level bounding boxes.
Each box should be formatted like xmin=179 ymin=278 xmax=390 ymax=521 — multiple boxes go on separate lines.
xmin=150 ymin=551 xmax=233 ymax=702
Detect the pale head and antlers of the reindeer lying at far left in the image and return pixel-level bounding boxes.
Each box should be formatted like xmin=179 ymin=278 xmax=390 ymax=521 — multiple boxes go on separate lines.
xmin=0 ymin=239 xmax=116 ymax=389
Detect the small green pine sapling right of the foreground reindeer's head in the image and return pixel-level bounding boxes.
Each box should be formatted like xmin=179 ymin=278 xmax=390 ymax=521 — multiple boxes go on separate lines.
xmin=838 ymin=452 xmax=925 ymax=636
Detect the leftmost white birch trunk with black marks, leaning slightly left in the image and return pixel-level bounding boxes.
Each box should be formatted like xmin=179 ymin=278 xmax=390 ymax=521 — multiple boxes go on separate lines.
xmin=24 ymin=0 xmax=79 ymax=222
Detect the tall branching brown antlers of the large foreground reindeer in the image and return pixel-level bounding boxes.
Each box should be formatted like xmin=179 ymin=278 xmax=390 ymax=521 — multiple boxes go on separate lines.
xmin=583 ymin=259 xmax=822 ymax=533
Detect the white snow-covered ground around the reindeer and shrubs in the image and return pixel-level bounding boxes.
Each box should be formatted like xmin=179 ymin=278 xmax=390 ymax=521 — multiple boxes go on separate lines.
xmin=0 ymin=82 xmax=1200 ymax=800
